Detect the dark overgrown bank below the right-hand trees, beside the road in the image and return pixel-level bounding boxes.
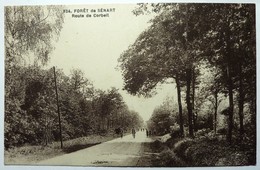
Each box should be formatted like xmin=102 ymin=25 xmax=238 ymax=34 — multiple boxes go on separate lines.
xmin=147 ymin=133 xmax=255 ymax=167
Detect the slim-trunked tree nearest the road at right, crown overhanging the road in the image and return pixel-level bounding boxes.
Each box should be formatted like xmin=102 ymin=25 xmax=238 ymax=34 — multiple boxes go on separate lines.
xmin=119 ymin=7 xmax=188 ymax=137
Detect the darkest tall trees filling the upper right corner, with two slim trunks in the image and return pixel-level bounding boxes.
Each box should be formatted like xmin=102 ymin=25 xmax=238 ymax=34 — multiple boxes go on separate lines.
xmin=201 ymin=4 xmax=255 ymax=144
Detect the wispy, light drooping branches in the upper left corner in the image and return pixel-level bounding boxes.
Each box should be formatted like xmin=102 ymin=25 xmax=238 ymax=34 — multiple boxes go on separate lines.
xmin=5 ymin=6 xmax=64 ymax=66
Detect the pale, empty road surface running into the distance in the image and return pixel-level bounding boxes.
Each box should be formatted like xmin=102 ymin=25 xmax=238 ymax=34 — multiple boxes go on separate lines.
xmin=38 ymin=131 xmax=152 ymax=166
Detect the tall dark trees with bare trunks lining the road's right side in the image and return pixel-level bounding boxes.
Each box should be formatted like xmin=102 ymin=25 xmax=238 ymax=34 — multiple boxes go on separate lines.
xmin=119 ymin=3 xmax=256 ymax=147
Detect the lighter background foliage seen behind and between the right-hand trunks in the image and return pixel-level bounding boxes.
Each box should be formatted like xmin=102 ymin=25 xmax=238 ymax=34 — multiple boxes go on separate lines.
xmin=147 ymin=95 xmax=213 ymax=138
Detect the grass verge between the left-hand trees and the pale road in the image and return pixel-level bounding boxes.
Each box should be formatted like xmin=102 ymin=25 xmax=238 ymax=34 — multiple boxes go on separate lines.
xmin=4 ymin=134 xmax=118 ymax=165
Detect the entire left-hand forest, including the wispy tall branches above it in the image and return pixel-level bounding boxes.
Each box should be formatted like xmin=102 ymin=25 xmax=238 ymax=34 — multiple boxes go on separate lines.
xmin=4 ymin=6 xmax=143 ymax=149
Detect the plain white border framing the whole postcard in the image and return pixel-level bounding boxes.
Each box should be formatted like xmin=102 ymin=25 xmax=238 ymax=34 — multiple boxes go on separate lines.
xmin=0 ymin=0 xmax=260 ymax=170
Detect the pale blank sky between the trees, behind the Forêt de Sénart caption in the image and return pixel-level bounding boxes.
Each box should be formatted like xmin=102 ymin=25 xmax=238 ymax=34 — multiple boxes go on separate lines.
xmin=49 ymin=4 xmax=177 ymax=121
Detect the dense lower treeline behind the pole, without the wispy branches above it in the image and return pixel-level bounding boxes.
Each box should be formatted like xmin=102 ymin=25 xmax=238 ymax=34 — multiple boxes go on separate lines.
xmin=5 ymin=66 xmax=143 ymax=148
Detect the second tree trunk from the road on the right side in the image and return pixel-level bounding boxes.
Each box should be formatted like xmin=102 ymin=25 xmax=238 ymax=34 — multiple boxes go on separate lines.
xmin=186 ymin=68 xmax=194 ymax=137
